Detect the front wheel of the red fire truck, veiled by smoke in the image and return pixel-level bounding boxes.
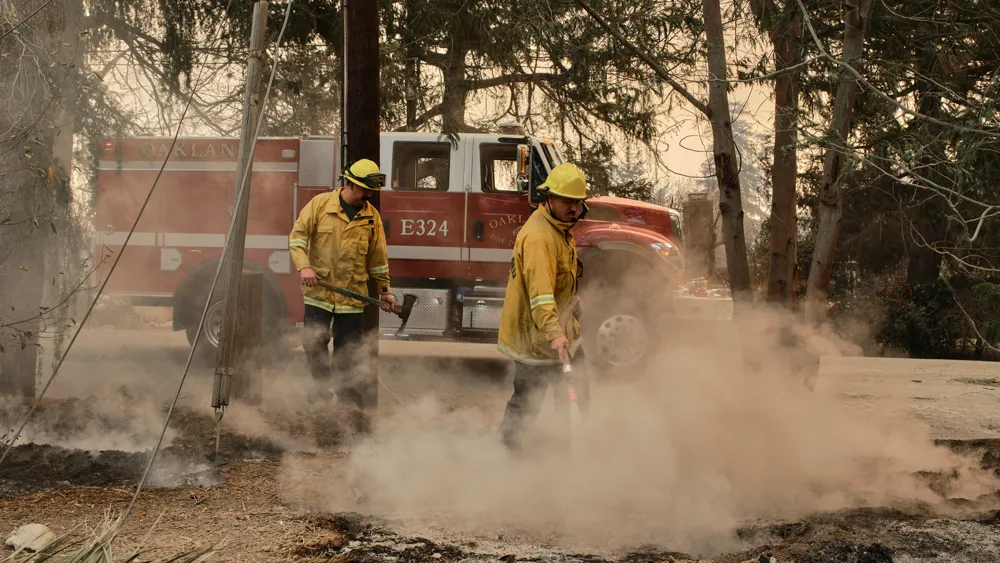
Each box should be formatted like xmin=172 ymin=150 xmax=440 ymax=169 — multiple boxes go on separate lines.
xmin=580 ymin=254 xmax=673 ymax=379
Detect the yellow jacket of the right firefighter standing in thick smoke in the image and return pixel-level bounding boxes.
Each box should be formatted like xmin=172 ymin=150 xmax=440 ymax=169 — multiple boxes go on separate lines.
xmin=497 ymin=205 xmax=580 ymax=365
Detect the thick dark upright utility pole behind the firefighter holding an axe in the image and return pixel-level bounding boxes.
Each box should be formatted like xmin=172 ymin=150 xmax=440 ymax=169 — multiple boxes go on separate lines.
xmin=334 ymin=0 xmax=380 ymax=410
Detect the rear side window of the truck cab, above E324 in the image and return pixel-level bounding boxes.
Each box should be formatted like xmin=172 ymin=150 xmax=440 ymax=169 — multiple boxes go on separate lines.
xmin=390 ymin=141 xmax=451 ymax=192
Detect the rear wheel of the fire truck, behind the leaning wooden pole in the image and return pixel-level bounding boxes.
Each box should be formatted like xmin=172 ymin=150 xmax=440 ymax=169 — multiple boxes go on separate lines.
xmin=174 ymin=261 xmax=290 ymax=364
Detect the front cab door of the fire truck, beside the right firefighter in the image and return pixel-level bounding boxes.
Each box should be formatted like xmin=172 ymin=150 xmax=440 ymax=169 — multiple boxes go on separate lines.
xmin=469 ymin=139 xmax=533 ymax=277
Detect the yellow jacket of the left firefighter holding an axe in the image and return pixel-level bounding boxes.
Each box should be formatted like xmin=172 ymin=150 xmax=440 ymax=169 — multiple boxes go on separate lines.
xmin=288 ymin=188 xmax=389 ymax=313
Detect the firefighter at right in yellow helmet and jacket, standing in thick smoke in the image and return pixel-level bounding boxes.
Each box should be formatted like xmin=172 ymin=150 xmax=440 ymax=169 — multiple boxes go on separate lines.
xmin=497 ymin=162 xmax=587 ymax=449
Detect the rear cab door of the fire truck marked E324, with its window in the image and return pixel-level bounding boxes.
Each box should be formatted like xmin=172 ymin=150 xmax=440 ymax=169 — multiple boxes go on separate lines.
xmin=381 ymin=133 xmax=468 ymax=279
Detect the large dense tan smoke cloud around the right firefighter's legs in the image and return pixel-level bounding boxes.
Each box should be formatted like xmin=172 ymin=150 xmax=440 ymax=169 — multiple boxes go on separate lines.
xmin=289 ymin=310 xmax=998 ymax=554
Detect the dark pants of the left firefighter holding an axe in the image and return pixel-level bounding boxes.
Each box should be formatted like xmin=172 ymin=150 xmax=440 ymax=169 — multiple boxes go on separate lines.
xmin=302 ymin=305 xmax=378 ymax=408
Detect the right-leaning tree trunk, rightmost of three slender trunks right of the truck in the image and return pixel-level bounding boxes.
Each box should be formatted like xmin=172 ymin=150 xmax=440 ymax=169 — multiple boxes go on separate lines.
xmin=805 ymin=0 xmax=873 ymax=323
